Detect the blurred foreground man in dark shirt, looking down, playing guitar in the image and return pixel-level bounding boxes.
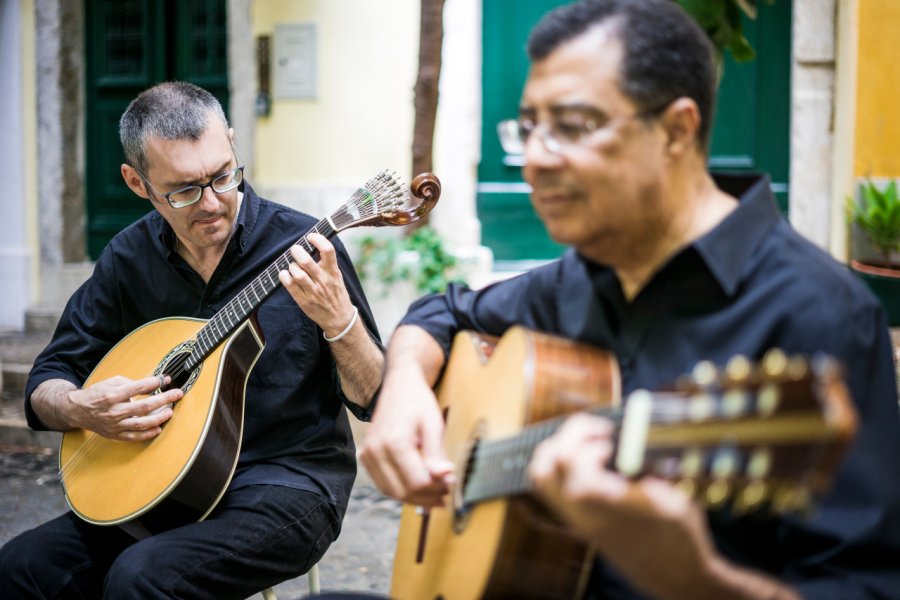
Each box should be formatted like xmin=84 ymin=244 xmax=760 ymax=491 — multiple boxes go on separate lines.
xmin=361 ymin=0 xmax=900 ymax=600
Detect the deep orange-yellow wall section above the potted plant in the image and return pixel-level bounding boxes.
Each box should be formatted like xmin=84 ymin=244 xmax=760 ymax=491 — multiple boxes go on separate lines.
xmin=854 ymin=0 xmax=900 ymax=178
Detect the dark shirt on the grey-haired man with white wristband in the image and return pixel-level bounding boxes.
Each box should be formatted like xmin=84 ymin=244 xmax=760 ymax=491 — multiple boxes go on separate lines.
xmin=25 ymin=183 xmax=380 ymax=510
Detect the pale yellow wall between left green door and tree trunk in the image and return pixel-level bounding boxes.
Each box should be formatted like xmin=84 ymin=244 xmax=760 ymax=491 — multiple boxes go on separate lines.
xmin=252 ymin=0 xmax=419 ymax=186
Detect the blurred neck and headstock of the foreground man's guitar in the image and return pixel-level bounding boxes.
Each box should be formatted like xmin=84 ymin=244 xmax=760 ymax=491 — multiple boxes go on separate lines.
xmin=461 ymin=357 xmax=855 ymax=510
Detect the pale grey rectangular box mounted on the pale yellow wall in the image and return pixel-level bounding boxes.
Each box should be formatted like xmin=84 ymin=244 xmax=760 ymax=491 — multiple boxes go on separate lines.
xmin=273 ymin=23 xmax=317 ymax=99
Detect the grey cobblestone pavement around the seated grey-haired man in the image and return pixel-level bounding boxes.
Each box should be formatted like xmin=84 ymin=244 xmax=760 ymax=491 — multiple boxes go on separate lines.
xmin=0 ymin=446 xmax=400 ymax=600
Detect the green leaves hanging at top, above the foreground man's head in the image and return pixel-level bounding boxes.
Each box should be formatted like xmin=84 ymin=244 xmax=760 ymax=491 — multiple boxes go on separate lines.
xmin=676 ymin=0 xmax=775 ymax=62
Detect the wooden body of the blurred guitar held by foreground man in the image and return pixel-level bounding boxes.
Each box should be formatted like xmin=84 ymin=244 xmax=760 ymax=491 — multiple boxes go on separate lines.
xmin=391 ymin=327 xmax=621 ymax=600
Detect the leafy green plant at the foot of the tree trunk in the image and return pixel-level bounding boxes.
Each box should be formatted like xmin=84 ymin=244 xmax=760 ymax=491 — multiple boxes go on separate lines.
xmin=355 ymin=225 xmax=462 ymax=294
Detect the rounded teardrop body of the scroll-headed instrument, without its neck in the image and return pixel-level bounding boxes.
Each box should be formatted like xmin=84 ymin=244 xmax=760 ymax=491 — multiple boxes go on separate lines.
xmin=59 ymin=318 xmax=264 ymax=538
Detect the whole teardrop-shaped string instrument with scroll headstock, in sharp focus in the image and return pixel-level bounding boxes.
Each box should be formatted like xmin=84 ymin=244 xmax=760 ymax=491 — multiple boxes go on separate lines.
xmin=59 ymin=171 xmax=440 ymax=537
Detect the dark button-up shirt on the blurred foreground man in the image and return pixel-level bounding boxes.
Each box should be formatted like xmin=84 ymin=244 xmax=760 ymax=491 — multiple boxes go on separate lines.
xmin=402 ymin=176 xmax=900 ymax=598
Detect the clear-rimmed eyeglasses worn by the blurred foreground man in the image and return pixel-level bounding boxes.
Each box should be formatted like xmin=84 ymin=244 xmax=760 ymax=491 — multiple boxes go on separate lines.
xmin=497 ymin=101 xmax=671 ymax=155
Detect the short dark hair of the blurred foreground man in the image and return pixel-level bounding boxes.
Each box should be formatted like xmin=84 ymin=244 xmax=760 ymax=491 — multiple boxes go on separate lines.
xmin=527 ymin=0 xmax=718 ymax=150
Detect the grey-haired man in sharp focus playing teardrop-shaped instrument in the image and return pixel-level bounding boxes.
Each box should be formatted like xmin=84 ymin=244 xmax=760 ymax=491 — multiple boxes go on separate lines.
xmin=0 ymin=82 xmax=383 ymax=600
